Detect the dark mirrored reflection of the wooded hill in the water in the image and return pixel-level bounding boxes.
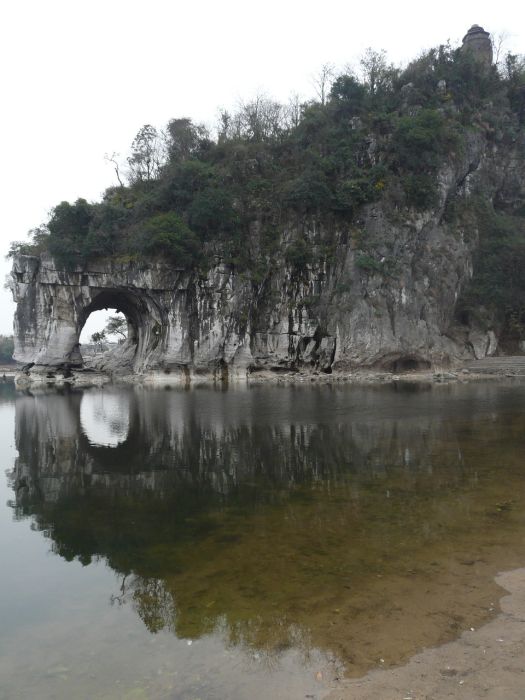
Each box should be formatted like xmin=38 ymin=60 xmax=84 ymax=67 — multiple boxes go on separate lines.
xmin=9 ymin=385 xmax=525 ymax=668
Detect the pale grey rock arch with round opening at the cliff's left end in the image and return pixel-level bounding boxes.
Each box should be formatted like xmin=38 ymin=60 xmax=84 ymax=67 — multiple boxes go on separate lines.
xmin=11 ymin=256 xmax=184 ymax=376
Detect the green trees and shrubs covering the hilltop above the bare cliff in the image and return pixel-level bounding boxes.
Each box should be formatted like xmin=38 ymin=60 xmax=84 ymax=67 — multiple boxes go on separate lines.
xmin=7 ymin=40 xmax=525 ymax=282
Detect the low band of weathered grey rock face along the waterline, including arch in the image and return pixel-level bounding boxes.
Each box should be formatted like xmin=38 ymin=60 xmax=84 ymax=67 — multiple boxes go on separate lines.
xmin=8 ymin=235 xmax=458 ymax=378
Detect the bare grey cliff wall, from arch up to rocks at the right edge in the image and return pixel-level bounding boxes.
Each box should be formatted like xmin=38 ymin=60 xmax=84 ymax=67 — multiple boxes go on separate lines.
xmin=11 ymin=131 xmax=525 ymax=379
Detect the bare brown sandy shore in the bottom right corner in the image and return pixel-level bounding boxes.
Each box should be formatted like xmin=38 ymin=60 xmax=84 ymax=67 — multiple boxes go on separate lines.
xmin=328 ymin=568 xmax=525 ymax=700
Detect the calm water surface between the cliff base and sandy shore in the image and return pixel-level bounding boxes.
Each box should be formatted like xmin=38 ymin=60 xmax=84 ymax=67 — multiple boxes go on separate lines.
xmin=0 ymin=383 xmax=525 ymax=700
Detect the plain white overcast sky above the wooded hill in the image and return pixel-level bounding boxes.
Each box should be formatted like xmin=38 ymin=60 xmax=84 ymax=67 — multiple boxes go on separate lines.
xmin=0 ymin=0 xmax=525 ymax=333
